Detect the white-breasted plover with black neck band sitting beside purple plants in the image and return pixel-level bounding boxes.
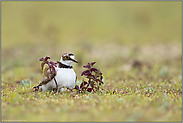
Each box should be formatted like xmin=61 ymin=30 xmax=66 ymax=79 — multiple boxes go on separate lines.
xmin=34 ymin=53 xmax=78 ymax=92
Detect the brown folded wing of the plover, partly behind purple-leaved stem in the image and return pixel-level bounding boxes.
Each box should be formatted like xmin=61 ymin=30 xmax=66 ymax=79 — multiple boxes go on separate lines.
xmin=39 ymin=68 xmax=56 ymax=85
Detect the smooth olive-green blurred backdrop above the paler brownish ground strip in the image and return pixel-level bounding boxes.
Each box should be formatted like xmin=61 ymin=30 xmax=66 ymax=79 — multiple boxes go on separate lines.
xmin=2 ymin=1 xmax=181 ymax=48
